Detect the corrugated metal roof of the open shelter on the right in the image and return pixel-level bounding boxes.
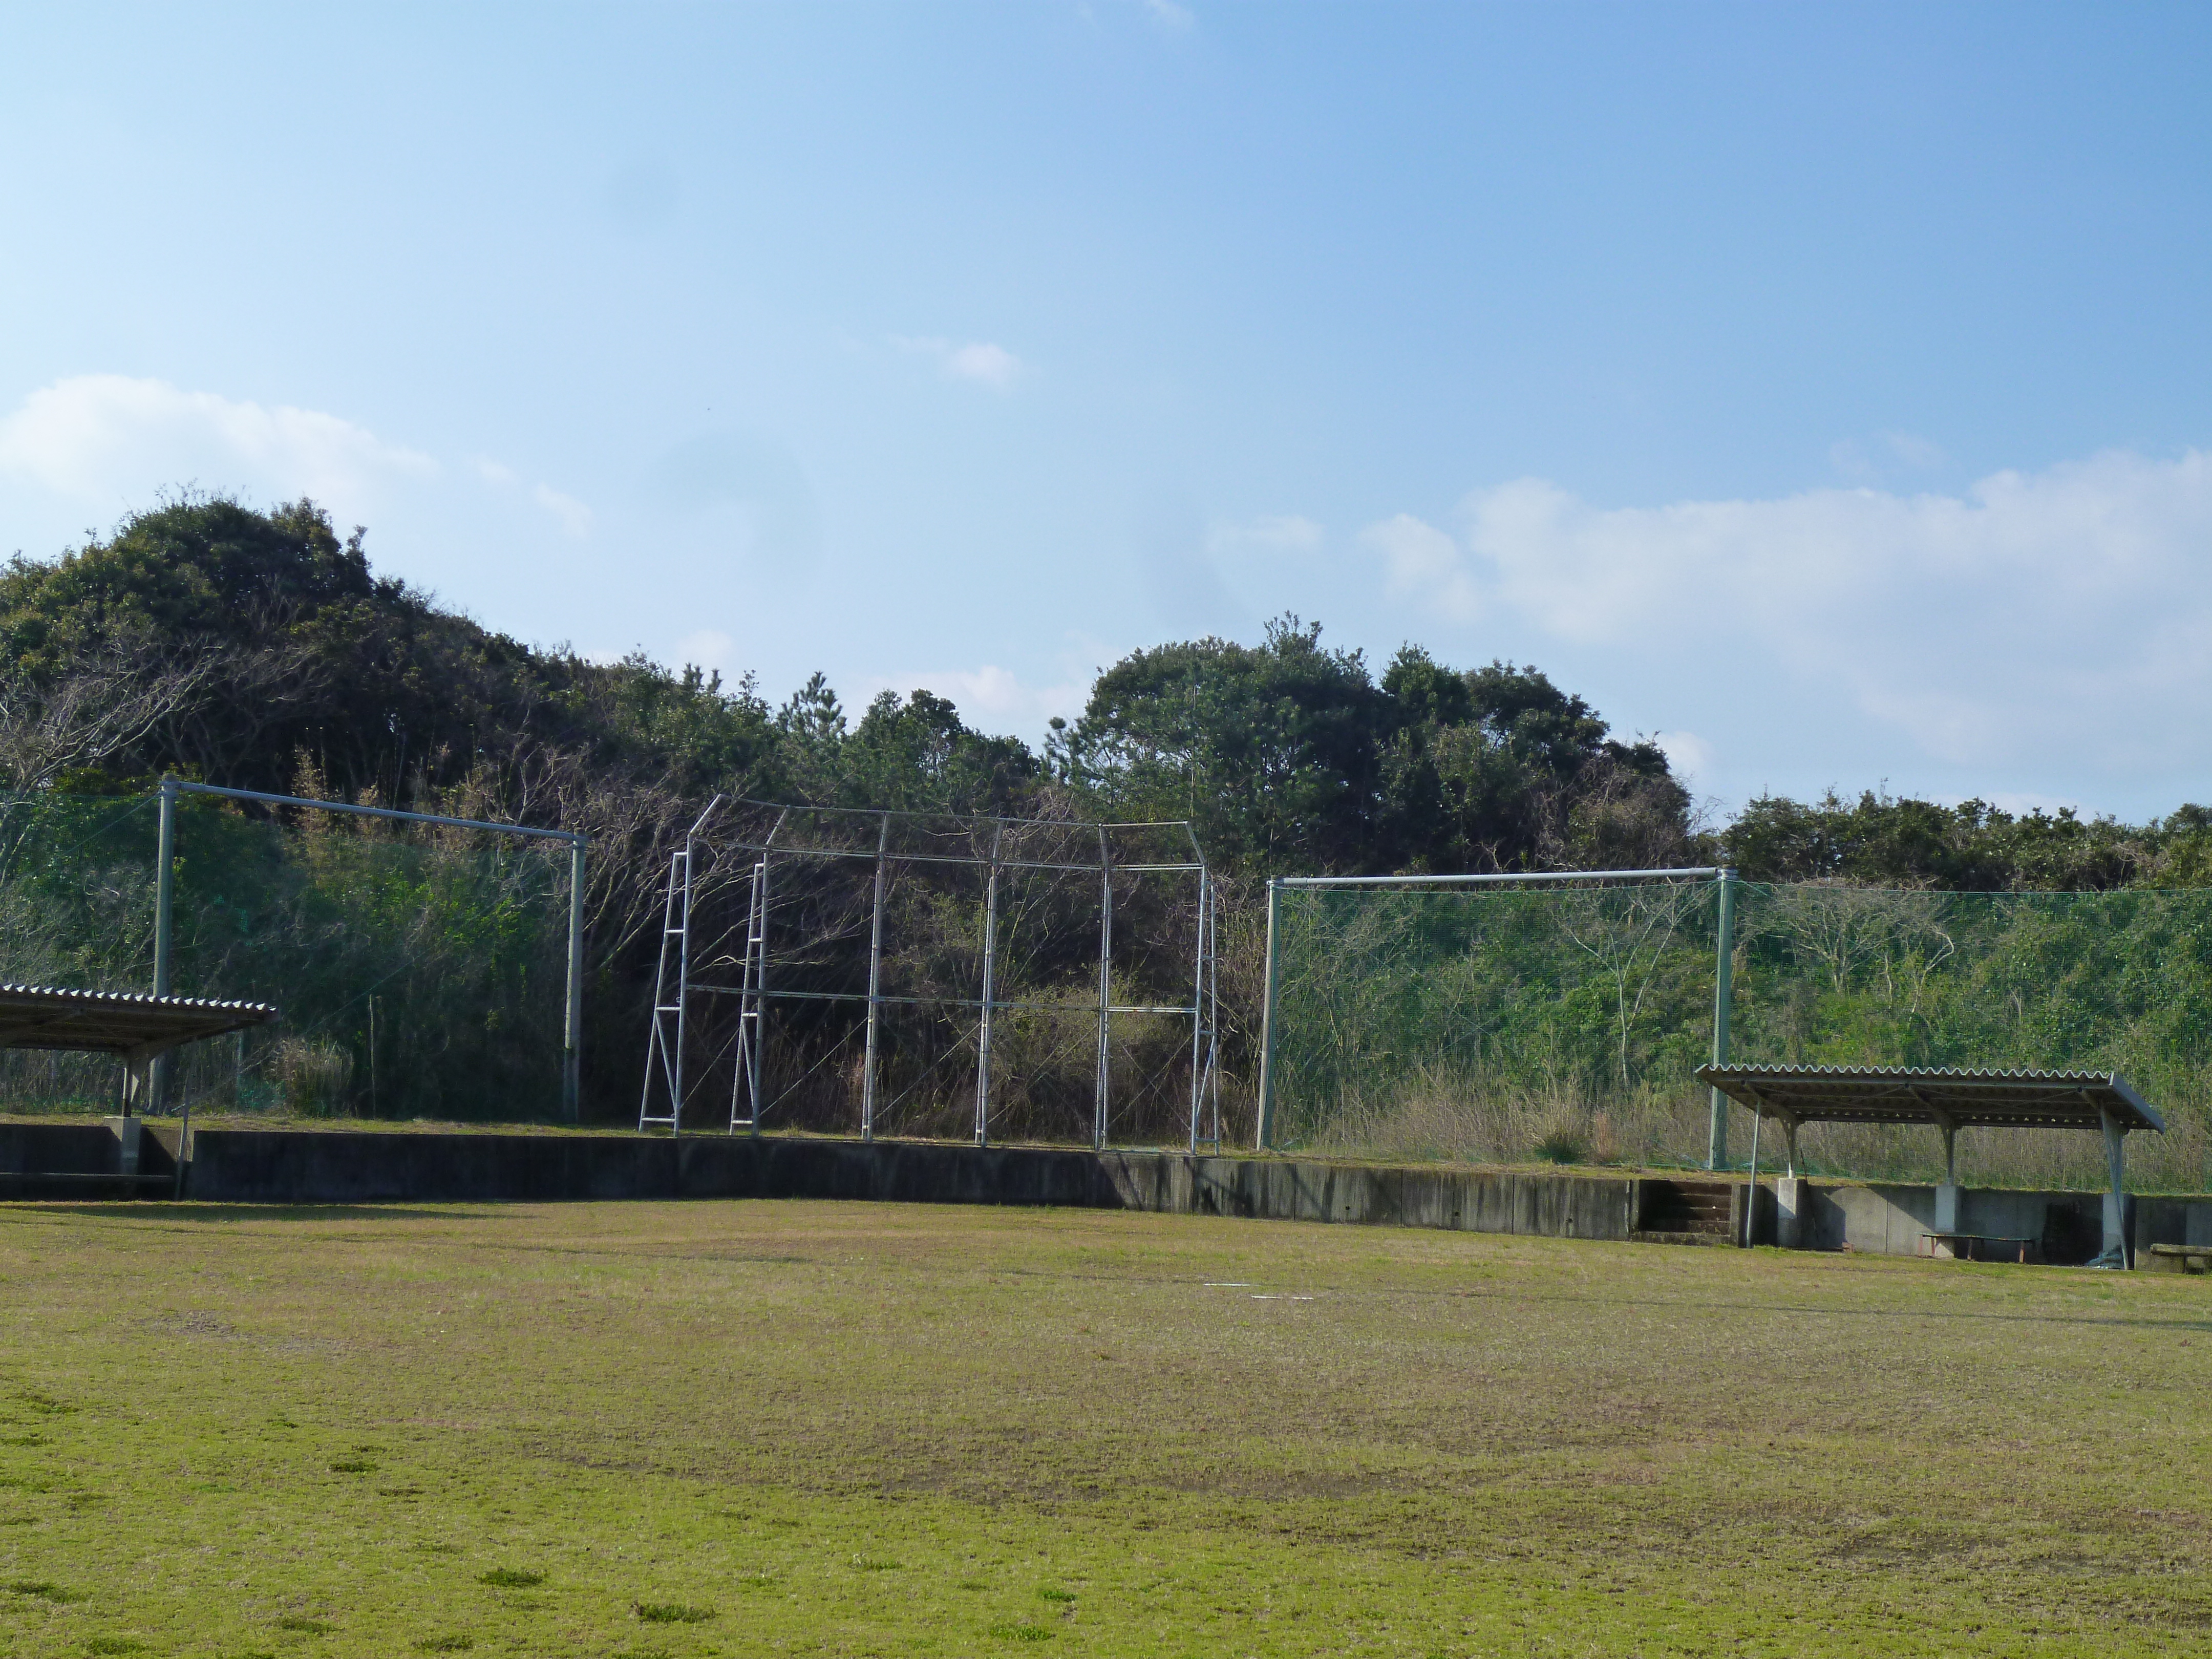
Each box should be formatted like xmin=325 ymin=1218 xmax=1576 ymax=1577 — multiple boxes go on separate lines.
xmin=1696 ymin=1066 xmax=2165 ymax=1131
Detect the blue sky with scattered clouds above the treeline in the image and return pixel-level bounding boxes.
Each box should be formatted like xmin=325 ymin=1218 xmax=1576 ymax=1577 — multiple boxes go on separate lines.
xmin=0 ymin=0 xmax=2212 ymax=816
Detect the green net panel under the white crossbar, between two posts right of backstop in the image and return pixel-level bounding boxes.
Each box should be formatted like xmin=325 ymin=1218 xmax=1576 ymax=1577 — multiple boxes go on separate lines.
xmin=1274 ymin=880 xmax=1716 ymax=1161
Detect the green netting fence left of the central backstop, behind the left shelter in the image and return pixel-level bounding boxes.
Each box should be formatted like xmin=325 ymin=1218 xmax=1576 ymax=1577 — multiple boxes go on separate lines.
xmin=0 ymin=794 xmax=568 ymax=1121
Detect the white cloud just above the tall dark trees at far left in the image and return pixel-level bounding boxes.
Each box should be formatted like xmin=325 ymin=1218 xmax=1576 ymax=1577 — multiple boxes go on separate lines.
xmin=0 ymin=374 xmax=438 ymax=509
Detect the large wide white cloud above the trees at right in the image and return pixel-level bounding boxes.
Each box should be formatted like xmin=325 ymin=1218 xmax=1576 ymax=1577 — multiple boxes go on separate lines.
xmin=1360 ymin=451 xmax=2212 ymax=768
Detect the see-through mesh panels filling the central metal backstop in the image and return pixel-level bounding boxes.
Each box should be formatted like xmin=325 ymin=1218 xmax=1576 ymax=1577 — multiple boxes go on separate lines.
xmin=639 ymin=801 xmax=1219 ymax=1146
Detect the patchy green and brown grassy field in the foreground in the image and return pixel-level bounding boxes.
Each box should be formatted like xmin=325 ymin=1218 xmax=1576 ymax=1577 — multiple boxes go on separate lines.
xmin=0 ymin=1203 xmax=2212 ymax=1659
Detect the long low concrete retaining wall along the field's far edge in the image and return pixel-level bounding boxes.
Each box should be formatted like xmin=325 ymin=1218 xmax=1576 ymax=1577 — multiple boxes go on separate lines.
xmin=13 ymin=1121 xmax=2212 ymax=1261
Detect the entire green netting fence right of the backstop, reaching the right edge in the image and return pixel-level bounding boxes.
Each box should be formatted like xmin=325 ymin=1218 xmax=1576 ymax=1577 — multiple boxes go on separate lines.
xmin=1272 ymin=878 xmax=2212 ymax=1190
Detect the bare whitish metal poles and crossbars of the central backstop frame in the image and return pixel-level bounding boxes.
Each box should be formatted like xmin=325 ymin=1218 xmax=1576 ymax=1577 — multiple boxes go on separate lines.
xmin=637 ymin=794 xmax=1221 ymax=1150
